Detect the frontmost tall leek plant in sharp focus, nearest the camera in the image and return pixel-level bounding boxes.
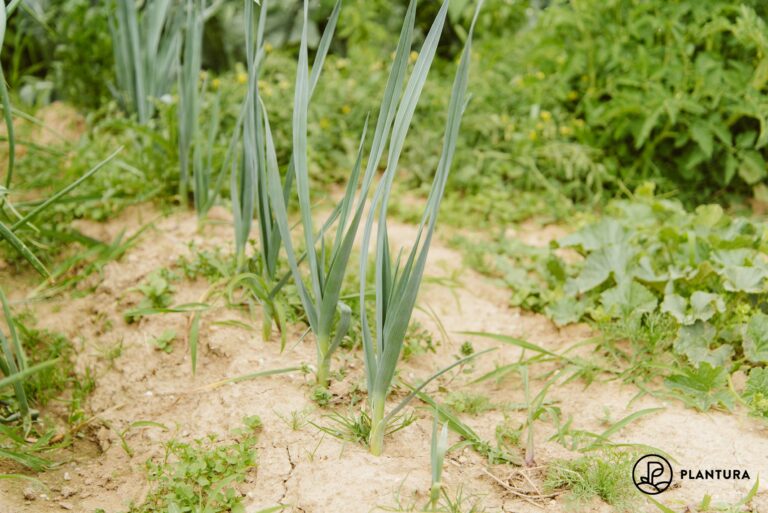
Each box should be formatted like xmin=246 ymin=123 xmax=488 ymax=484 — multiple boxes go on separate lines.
xmin=360 ymin=0 xmax=482 ymax=455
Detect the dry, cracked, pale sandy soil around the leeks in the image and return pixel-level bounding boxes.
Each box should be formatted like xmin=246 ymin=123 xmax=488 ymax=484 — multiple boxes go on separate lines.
xmin=0 ymin=205 xmax=768 ymax=513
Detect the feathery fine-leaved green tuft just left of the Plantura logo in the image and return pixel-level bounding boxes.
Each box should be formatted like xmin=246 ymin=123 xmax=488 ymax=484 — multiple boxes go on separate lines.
xmin=545 ymin=451 xmax=637 ymax=511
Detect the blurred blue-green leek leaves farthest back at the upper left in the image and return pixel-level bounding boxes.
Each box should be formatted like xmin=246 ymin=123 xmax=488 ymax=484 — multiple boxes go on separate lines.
xmin=109 ymin=0 xmax=183 ymax=123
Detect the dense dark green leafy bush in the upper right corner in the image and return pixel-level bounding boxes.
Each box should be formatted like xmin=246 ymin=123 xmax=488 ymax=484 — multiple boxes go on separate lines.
xmin=508 ymin=0 xmax=768 ymax=201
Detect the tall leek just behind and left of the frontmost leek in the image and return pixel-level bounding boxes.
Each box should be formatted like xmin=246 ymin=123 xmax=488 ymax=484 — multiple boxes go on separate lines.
xmin=263 ymin=1 xmax=447 ymax=385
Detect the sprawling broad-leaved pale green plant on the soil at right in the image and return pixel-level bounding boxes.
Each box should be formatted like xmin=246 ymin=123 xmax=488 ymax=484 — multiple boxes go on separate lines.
xmin=459 ymin=186 xmax=768 ymax=390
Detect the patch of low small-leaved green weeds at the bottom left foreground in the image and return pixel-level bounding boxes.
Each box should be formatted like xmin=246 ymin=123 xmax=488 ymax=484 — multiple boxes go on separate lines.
xmin=129 ymin=417 xmax=261 ymax=513
